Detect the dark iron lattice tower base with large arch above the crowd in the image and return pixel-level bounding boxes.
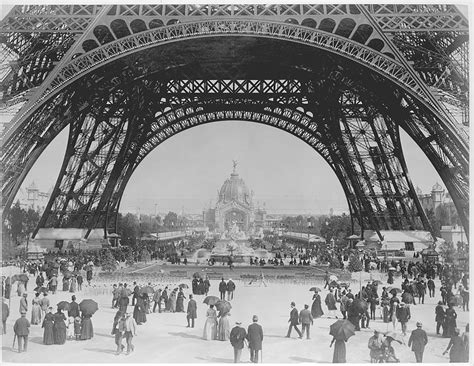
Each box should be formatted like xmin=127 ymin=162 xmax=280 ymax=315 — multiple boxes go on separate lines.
xmin=0 ymin=4 xmax=469 ymax=240
